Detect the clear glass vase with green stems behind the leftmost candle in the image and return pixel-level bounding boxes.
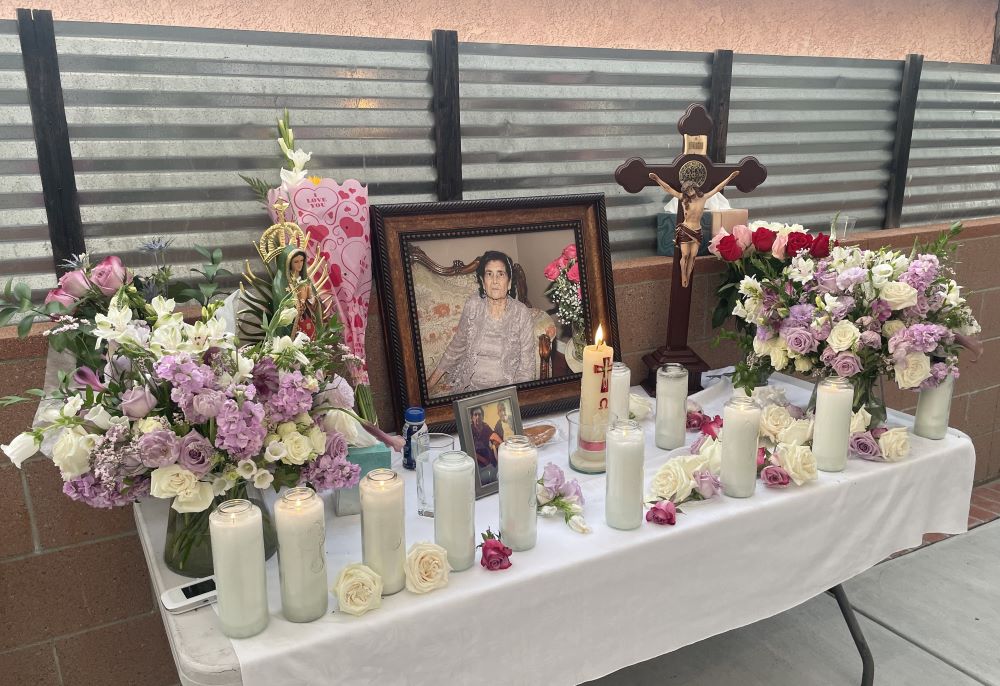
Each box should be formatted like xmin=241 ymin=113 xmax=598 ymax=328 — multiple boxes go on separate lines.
xmin=163 ymin=481 xmax=278 ymax=578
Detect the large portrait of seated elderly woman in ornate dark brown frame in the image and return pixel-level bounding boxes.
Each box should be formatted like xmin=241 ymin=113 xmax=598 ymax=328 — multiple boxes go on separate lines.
xmin=371 ymin=194 xmax=620 ymax=431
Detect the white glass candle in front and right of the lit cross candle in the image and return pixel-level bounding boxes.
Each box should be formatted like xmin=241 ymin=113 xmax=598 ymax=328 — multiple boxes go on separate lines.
xmin=604 ymin=419 xmax=646 ymax=529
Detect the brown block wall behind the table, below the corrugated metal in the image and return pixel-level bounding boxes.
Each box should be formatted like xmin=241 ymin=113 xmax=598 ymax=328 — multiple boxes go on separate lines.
xmin=0 ymin=218 xmax=1000 ymax=686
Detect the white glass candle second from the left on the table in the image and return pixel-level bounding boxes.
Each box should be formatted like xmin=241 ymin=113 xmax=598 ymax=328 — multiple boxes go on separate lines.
xmin=274 ymin=486 xmax=329 ymax=622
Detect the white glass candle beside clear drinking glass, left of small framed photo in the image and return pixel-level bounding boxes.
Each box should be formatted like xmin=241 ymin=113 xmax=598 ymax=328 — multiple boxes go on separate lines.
xmin=434 ymin=450 xmax=476 ymax=572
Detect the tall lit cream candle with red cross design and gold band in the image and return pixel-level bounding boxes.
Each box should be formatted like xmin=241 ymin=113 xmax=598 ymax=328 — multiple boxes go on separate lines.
xmin=570 ymin=326 xmax=615 ymax=474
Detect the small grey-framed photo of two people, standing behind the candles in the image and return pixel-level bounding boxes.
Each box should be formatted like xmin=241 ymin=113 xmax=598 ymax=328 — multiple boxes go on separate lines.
xmin=453 ymin=386 xmax=522 ymax=498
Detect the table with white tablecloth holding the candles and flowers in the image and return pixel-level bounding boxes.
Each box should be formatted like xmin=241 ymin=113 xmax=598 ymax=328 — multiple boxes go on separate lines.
xmin=135 ymin=374 xmax=975 ymax=686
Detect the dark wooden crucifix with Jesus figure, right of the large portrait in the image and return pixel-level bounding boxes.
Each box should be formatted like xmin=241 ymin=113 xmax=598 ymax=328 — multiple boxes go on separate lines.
xmin=615 ymin=104 xmax=767 ymax=395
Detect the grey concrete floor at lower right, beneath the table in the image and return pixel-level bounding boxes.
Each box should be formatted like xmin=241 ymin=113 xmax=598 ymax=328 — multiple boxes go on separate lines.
xmin=588 ymin=520 xmax=1000 ymax=686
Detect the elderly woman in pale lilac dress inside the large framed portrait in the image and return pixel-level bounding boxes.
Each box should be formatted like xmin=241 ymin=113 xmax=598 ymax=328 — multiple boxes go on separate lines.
xmin=427 ymin=250 xmax=537 ymax=394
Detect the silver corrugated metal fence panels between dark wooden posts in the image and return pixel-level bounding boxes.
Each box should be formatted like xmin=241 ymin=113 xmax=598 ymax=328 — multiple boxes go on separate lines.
xmin=0 ymin=16 xmax=1000 ymax=288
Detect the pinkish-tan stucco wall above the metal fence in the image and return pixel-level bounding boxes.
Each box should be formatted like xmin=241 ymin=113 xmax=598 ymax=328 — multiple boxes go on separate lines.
xmin=0 ymin=0 xmax=997 ymax=63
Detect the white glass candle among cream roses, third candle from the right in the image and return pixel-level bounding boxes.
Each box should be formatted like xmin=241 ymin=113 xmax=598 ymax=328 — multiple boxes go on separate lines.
xmin=719 ymin=396 xmax=760 ymax=498
